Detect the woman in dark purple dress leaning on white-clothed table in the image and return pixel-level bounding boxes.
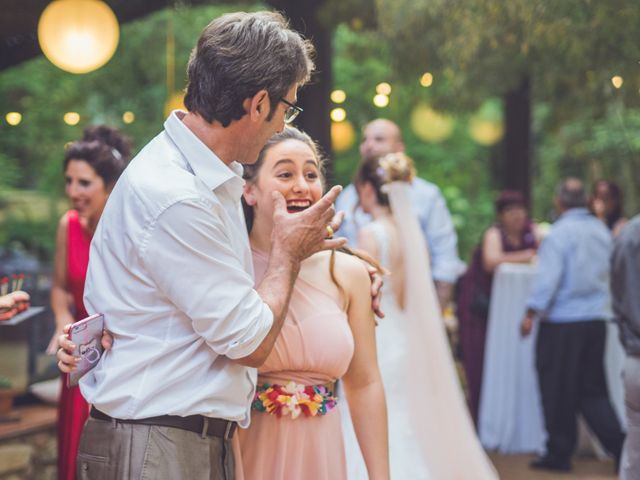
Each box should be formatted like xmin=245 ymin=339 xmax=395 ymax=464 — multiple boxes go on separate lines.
xmin=456 ymin=191 xmax=538 ymax=425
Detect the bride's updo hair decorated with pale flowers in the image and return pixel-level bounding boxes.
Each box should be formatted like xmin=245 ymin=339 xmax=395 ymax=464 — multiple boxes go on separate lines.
xmin=353 ymin=152 xmax=416 ymax=207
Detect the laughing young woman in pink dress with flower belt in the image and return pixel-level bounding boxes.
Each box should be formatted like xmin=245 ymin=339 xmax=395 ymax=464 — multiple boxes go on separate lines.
xmin=236 ymin=128 xmax=389 ymax=480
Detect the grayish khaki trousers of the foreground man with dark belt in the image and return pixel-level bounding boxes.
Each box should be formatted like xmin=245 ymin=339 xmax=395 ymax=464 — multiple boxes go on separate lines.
xmin=77 ymin=417 xmax=234 ymax=480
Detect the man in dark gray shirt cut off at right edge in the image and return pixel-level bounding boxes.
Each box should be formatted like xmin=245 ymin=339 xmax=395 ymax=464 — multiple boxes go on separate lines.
xmin=611 ymin=215 xmax=640 ymax=480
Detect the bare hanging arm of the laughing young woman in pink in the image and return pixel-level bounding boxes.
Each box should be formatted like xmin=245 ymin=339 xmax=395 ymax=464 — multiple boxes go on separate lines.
xmin=336 ymin=257 xmax=389 ymax=480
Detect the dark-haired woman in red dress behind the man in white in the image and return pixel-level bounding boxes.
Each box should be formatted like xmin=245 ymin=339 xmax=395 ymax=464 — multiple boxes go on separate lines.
xmin=47 ymin=126 xmax=131 ymax=480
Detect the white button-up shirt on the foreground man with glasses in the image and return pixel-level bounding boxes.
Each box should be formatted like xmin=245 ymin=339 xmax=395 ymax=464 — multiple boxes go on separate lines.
xmin=80 ymin=112 xmax=273 ymax=426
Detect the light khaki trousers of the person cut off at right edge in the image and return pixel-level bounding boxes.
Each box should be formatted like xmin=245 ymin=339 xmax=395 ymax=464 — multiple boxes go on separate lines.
xmin=620 ymin=356 xmax=640 ymax=480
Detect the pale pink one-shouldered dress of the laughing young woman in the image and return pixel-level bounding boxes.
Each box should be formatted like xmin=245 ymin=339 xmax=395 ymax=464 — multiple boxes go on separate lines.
xmin=236 ymin=251 xmax=354 ymax=480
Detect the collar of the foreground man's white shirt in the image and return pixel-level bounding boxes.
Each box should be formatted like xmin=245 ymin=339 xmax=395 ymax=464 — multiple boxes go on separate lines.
xmin=164 ymin=110 xmax=244 ymax=195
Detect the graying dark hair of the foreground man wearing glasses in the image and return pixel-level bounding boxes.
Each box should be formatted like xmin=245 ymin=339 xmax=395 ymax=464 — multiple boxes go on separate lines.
xmin=184 ymin=12 xmax=314 ymax=127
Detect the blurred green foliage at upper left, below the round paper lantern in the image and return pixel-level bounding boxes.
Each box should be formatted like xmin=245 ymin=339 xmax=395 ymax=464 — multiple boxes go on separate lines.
xmin=0 ymin=4 xmax=256 ymax=258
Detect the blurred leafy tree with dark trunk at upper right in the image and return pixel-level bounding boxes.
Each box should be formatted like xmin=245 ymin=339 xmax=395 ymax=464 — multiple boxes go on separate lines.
xmin=376 ymin=0 xmax=640 ymax=207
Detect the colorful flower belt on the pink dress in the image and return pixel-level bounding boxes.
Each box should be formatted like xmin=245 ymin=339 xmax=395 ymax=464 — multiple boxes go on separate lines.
xmin=251 ymin=382 xmax=338 ymax=418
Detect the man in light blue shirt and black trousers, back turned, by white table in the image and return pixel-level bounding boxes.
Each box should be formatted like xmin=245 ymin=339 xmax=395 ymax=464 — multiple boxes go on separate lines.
xmin=521 ymin=178 xmax=624 ymax=471
